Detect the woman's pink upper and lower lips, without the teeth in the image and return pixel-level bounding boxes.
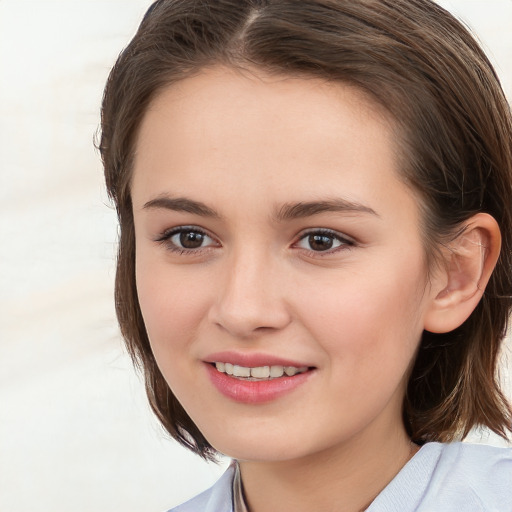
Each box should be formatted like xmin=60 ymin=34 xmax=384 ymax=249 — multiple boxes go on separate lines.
xmin=205 ymin=352 xmax=313 ymax=404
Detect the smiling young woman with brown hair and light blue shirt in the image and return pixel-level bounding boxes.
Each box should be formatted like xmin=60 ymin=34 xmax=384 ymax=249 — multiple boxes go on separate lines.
xmin=100 ymin=0 xmax=512 ymax=512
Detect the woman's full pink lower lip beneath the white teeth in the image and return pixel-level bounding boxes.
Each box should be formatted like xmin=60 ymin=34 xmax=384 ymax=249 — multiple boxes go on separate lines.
xmin=206 ymin=363 xmax=313 ymax=404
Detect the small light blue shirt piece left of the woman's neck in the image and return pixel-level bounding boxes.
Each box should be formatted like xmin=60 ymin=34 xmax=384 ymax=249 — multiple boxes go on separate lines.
xmin=168 ymin=465 xmax=234 ymax=512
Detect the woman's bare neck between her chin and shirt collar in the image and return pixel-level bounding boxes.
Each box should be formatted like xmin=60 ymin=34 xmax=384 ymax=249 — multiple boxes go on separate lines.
xmin=239 ymin=424 xmax=418 ymax=512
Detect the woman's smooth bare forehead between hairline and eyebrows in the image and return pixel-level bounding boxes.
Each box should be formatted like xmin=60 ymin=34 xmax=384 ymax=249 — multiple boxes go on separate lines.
xmin=132 ymin=67 xmax=404 ymax=208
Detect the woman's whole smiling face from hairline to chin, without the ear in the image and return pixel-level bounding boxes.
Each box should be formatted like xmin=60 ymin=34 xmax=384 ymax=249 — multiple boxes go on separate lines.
xmin=132 ymin=68 xmax=431 ymax=460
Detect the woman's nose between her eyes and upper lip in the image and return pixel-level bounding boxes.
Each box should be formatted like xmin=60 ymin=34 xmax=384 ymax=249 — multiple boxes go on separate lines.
xmin=209 ymin=251 xmax=291 ymax=338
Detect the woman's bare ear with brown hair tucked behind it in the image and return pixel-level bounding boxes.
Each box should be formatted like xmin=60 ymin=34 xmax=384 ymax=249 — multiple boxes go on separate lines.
xmin=424 ymin=213 xmax=501 ymax=333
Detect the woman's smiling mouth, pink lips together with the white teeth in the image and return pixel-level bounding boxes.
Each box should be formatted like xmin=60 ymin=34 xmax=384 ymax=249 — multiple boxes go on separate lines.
xmin=205 ymin=352 xmax=315 ymax=404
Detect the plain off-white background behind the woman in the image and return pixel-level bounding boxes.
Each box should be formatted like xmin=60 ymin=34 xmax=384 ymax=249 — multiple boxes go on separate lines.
xmin=0 ymin=0 xmax=512 ymax=512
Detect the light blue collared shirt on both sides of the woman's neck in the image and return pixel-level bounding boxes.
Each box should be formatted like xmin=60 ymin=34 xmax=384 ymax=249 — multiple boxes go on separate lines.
xmin=168 ymin=443 xmax=512 ymax=512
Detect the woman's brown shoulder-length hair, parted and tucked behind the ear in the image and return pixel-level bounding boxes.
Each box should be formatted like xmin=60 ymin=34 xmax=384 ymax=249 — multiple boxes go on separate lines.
xmin=99 ymin=0 xmax=512 ymax=459
